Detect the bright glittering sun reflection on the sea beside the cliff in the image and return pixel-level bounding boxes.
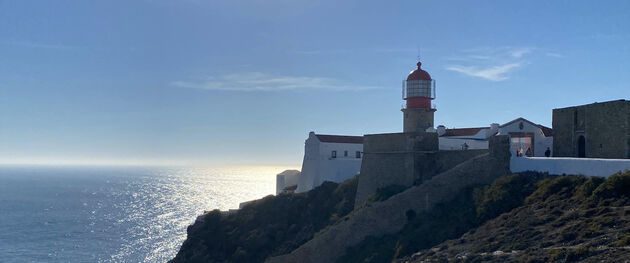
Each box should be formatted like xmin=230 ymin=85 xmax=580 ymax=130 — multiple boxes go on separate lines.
xmin=104 ymin=166 xmax=295 ymax=262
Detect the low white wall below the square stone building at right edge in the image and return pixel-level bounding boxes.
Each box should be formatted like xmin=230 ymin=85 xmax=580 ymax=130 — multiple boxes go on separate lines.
xmin=510 ymin=157 xmax=630 ymax=177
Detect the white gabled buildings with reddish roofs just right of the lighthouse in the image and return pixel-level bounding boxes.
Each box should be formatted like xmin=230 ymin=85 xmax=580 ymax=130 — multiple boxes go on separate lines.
xmin=437 ymin=118 xmax=553 ymax=157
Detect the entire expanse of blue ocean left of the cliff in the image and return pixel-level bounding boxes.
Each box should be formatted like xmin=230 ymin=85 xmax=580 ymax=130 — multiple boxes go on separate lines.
xmin=0 ymin=166 xmax=287 ymax=262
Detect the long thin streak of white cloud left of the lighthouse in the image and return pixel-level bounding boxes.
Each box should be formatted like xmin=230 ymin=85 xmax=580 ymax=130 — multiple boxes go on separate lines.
xmin=171 ymin=72 xmax=380 ymax=91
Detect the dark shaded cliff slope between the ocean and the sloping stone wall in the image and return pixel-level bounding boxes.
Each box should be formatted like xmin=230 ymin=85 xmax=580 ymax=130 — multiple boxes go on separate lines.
xmin=170 ymin=179 xmax=357 ymax=263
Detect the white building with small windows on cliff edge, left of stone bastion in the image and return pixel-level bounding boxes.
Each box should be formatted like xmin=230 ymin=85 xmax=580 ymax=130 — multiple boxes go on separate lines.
xmin=295 ymin=132 xmax=363 ymax=193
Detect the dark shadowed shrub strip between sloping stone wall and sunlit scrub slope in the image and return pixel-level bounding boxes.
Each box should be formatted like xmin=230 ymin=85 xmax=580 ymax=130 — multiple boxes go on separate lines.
xmin=337 ymin=173 xmax=550 ymax=262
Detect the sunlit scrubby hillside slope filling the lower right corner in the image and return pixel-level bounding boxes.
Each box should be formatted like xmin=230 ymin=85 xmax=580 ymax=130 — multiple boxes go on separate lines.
xmin=399 ymin=172 xmax=630 ymax=262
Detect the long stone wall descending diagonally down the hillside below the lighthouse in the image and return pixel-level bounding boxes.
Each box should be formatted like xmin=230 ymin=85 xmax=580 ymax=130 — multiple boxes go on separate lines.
xmin=267 ymin=136 xmax=510 ymax=263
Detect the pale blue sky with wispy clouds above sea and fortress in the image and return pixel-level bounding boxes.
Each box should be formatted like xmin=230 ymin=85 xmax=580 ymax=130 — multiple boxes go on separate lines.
xmin=0 ymin=0 xmax=630 ymax=166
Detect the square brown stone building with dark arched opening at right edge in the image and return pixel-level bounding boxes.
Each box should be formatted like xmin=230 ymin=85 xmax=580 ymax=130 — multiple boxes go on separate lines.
xmin=552 ymin=100 xmax=630 ymax=159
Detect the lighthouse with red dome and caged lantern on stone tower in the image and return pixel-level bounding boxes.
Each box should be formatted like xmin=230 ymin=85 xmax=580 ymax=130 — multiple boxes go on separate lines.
xmin=402 ymin=61 xmax=436 ymax=132
